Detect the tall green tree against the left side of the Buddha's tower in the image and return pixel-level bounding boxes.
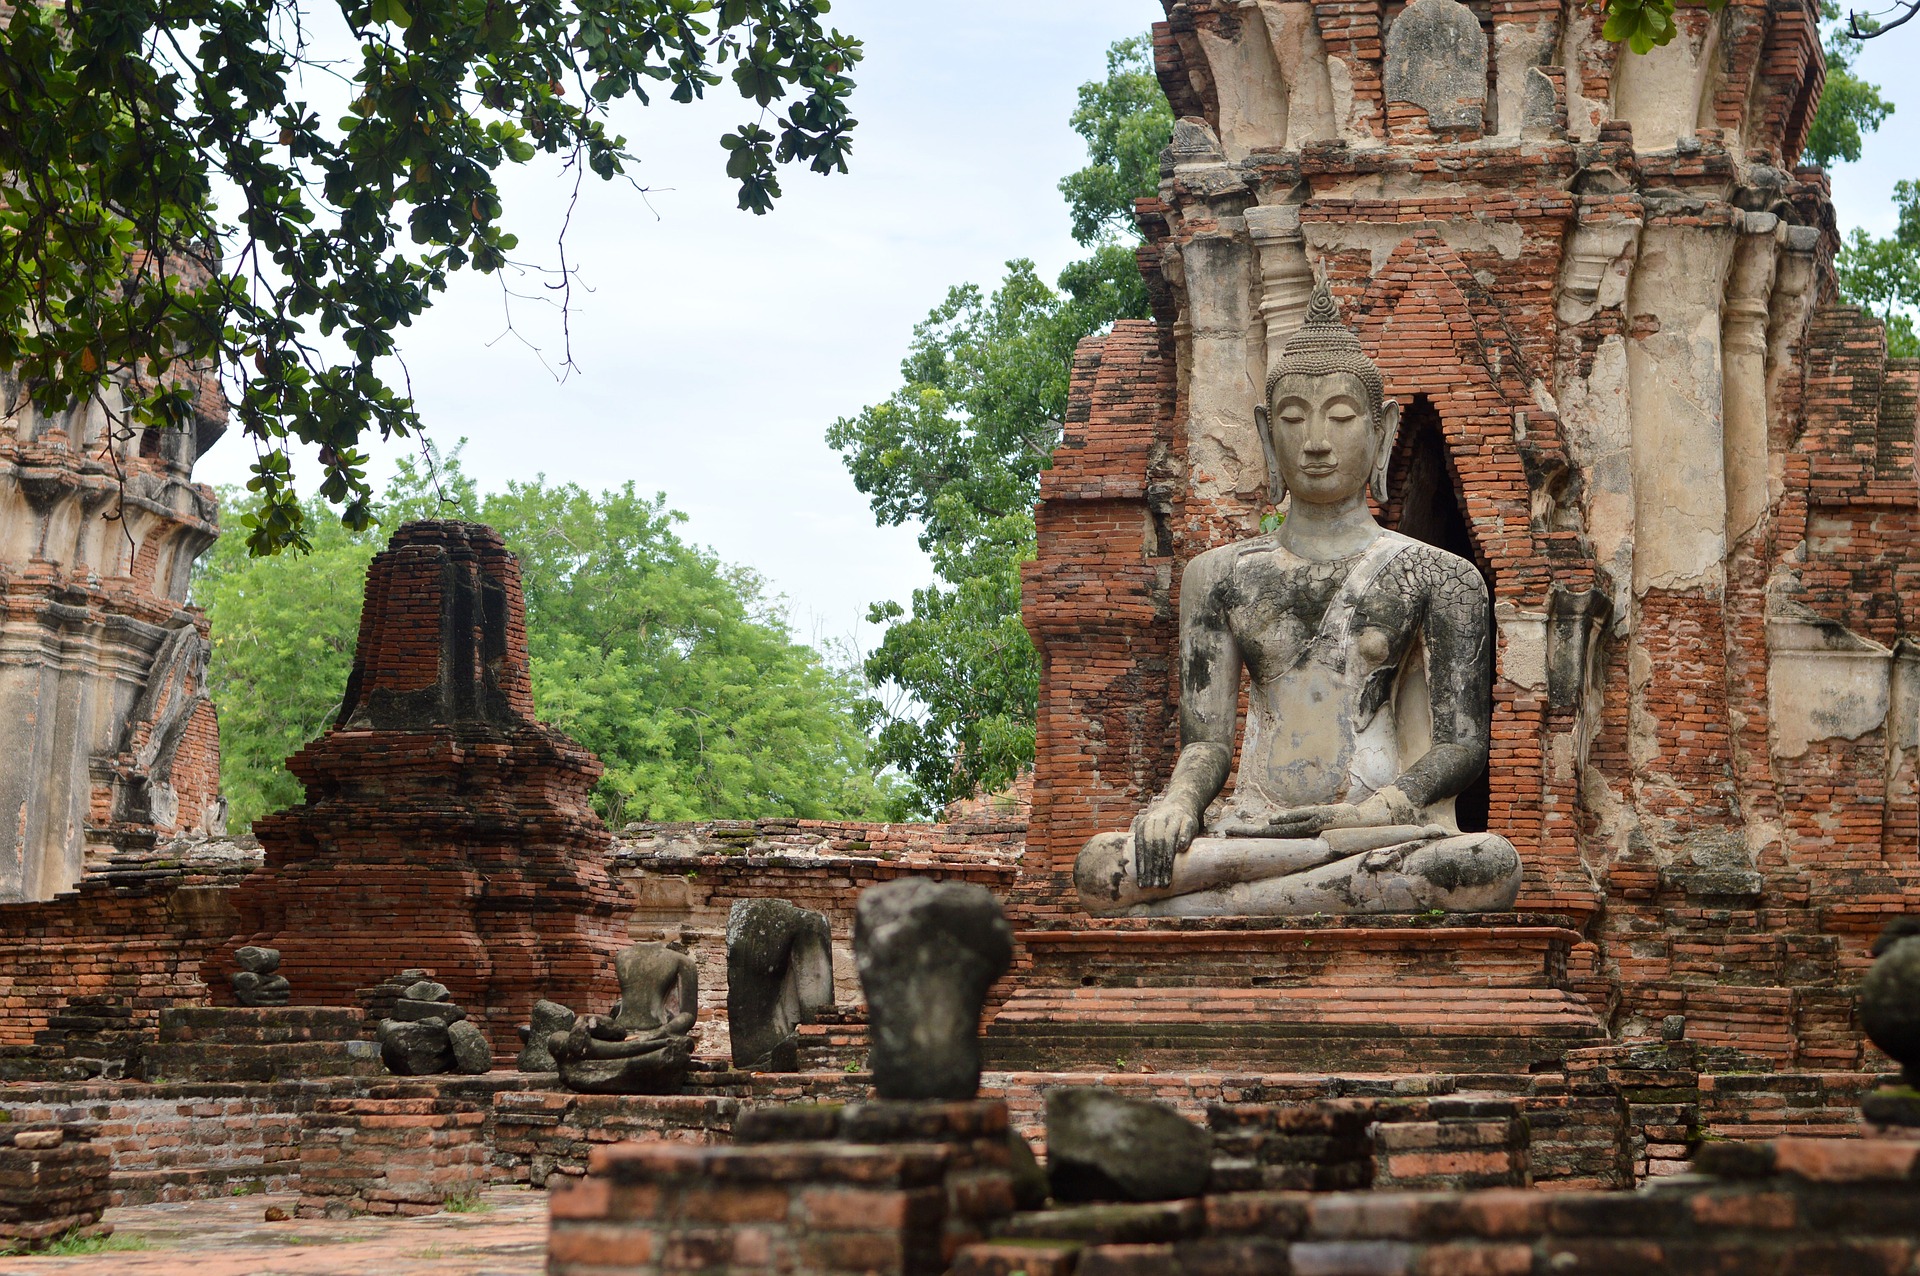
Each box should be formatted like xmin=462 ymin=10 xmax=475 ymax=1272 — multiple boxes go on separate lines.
xmin=828 ymin=36 xmax=1173 ymax=812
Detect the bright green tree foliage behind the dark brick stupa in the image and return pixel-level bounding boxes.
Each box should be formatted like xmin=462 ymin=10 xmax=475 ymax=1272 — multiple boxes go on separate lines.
xmin=194 ymin=445 xmax=904 ymax=827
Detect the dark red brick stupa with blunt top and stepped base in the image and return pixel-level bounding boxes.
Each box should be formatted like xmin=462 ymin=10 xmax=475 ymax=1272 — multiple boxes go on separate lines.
xmin=209 ymin=520 xmax=624 ymax=1053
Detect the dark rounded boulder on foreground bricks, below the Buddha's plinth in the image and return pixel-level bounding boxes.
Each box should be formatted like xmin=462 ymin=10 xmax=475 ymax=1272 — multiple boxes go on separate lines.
xmin=1046 ymin=1086 xmax=1213 ymax=1201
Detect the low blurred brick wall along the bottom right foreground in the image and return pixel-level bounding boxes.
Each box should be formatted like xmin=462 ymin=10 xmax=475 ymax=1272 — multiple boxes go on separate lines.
xmin=952 ymin=1140 xmax=1920 ymax=1276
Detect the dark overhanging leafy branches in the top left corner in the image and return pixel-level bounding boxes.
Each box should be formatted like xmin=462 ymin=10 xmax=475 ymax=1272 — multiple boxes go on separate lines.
xmin=0 ymin=0 xmax=860 ymax=553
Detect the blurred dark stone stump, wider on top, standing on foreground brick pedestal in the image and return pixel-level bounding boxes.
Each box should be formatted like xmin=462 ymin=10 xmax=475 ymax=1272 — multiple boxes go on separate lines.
xmin=852 ymin=877 xmax=1014 ymax=1099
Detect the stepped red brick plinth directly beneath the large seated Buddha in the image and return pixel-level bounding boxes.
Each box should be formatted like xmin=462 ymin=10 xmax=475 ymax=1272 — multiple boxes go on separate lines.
xmin=985 ymin=917 xmax=1605 ymax=1073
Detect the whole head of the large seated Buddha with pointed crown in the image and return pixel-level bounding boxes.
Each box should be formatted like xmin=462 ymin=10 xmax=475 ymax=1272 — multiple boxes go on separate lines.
xmin=1254 ymin=284 xmax=1400 ymax=505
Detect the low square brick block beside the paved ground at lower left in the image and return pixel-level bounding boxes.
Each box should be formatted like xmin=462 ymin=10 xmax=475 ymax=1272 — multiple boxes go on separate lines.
xmin=300 ymin=1098 xmax=492 ymax=1218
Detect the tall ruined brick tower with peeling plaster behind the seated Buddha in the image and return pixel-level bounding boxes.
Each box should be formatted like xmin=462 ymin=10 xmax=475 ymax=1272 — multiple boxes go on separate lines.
xmin=1021 ymin=0 xmax=1920 ymax=1069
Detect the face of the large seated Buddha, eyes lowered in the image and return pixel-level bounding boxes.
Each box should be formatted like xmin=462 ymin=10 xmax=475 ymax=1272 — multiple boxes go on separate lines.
xmin=1265 ymin=372 xmax=1400 ymax=505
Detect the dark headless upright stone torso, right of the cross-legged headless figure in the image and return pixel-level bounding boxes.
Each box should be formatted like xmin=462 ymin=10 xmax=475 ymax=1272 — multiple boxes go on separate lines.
xmin=726 ymin=900 xmax=833 ymax=1073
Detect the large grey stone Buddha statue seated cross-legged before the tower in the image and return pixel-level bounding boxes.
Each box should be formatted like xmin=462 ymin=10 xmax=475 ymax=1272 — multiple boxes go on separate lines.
xmin=1073 ymin=286 xmax=1521 ymax=917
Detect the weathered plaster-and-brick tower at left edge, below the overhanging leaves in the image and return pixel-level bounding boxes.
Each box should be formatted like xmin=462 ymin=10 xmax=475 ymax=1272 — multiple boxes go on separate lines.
xmin=0 ymin=374 xmax=227 ymax=902
